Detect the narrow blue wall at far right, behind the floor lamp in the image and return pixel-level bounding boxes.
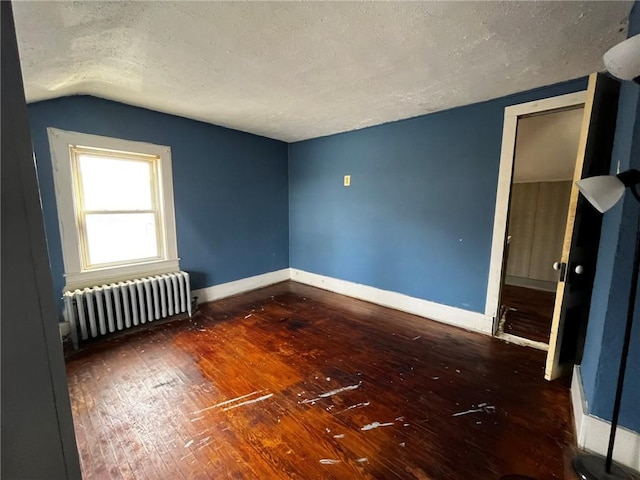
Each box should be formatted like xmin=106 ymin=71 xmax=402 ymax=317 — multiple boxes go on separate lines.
xmin=581 ymin=2 xmax=640 ymax=432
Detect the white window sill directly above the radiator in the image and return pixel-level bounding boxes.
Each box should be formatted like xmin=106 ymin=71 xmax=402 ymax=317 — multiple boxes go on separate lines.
xmin=64 ymin=259 xmax=180 ymax=292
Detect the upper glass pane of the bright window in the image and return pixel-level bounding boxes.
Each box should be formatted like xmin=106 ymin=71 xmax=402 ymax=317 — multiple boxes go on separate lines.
xmin=78 ymin=154 xmax=152 ymax=210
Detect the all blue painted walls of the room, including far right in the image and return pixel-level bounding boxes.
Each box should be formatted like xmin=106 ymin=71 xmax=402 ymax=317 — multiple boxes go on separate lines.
xmin=29 ymin=9 xmax=640 ymax=431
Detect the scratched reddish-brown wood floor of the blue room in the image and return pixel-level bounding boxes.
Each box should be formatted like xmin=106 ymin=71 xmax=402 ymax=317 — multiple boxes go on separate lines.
xmin=67 ymin=282 xmax=576 ymax=480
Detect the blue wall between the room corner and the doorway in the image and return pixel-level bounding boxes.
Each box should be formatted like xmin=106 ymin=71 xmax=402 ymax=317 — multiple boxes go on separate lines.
xmin=289 ymin=79 xmax=586 ymax=313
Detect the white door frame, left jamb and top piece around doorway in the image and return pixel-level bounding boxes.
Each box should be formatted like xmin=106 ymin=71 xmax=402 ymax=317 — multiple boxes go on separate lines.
xmin=485 ymin=90 xmax=587 ymax=335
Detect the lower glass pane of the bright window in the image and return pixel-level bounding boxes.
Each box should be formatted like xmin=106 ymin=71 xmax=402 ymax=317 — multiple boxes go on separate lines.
xmin=85 ymin=213 xmax=158 ymax=266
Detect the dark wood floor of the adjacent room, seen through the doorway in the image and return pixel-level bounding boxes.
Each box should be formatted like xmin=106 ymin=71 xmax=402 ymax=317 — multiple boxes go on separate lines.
xmin=501 ymin=285 xmax=556 ymax=343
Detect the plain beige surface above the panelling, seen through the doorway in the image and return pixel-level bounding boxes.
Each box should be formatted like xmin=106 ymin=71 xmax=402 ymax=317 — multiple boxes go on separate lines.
xmin=513 ymin=107 xmax=584 ymax=183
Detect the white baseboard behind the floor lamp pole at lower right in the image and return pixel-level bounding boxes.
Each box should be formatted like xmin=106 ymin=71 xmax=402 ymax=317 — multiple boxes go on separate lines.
xmin=571 ymin=365 xmax=640 ymax=471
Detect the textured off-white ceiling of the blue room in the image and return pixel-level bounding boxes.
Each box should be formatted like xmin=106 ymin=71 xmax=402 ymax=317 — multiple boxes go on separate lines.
xmin=14 ymin=1 xmax=632 ymax=142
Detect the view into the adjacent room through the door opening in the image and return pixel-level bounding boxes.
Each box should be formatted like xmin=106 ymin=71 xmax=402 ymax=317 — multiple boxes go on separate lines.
xmin=496 ymin=108 xmax=584 ymax=350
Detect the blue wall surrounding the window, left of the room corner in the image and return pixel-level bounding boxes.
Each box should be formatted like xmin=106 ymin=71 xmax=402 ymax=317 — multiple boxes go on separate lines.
xmin=29 ymin=96 xmax=289 ymax=312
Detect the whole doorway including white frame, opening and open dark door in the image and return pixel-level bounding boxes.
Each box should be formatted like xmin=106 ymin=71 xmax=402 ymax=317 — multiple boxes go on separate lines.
xmin=485 ymin=73 xmax=620 ymax=380
